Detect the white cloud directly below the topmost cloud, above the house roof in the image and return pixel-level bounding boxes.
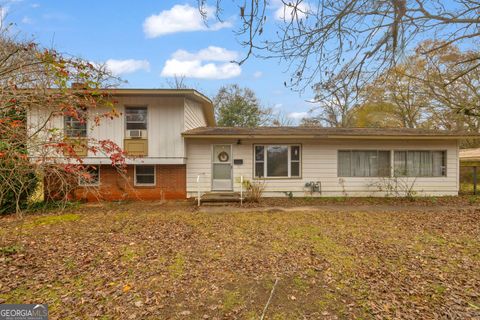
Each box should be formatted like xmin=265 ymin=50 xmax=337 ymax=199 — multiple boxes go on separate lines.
xmin=161 ymin=47 xmax=242 ymax=79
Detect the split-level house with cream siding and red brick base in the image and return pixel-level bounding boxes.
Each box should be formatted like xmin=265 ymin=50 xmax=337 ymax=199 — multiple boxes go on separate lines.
xmin=29 ymin=89 xmax=475 ymax=200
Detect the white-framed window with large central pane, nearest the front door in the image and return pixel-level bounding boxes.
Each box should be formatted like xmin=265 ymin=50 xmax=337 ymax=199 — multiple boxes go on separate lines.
xmin=254 ymin=145 xmax=301 ymax=178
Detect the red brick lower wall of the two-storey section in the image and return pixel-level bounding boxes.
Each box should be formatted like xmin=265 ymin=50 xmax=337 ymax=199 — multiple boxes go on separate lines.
xmin=74 ymin=165 xmax=187 ymax=201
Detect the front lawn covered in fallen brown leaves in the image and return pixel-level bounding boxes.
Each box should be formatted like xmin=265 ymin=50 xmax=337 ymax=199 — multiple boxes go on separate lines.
xmin=0 ymin=203 xmax=480 ymax=319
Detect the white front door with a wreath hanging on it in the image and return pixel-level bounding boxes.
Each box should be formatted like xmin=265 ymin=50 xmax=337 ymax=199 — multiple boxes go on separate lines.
xmin=212 ymin=144 xmax=233 ymax=191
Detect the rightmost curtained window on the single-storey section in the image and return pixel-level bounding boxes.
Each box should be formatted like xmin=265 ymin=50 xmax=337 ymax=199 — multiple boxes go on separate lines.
xmin=394 ymin=150 xmax=446 ymax=177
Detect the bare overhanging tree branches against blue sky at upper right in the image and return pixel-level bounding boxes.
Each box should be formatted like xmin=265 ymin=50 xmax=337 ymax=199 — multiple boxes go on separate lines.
xmin=197 ymin=0 xmax=480 ymax=88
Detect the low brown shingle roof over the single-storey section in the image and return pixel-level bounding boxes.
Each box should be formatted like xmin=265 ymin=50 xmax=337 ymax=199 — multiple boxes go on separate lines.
xmin=183 ymin=127 xmax=480 ymax=138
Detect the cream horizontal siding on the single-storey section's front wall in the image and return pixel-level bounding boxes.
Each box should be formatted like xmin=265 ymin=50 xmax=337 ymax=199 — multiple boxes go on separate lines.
xmin=187 ymin=139 xmax=458 ymax=196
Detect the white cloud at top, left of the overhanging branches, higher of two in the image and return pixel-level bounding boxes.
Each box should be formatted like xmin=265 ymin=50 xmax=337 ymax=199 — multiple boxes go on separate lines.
xmin=143 ymin=4 xmax=232 ymax=38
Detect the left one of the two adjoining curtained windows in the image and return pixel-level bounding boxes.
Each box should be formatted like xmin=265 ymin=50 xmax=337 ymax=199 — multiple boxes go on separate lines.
xmin=338 ymin=150 xmax=390 ymax=177
